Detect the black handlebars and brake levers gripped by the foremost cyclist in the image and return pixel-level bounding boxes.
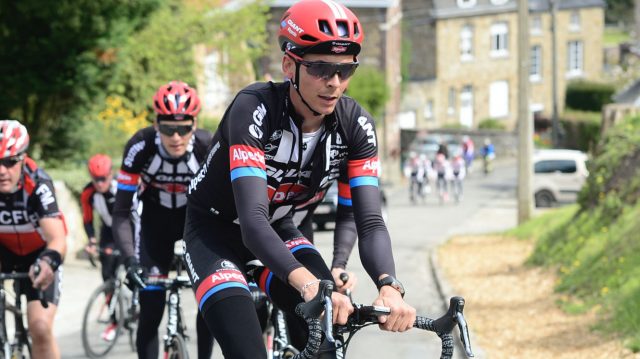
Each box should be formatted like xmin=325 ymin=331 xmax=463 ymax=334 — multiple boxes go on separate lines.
xmin=292 ymin=280 xmax=473 ymax=359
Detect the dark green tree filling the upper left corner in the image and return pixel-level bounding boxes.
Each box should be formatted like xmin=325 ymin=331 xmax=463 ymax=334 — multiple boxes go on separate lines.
xmin=0 ymin=0 xmax=161 ymax=157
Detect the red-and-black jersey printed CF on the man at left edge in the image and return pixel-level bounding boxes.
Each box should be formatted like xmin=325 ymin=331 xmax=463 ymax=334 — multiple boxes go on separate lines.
xmin=0 ymin=157 xmax=66 ymax=256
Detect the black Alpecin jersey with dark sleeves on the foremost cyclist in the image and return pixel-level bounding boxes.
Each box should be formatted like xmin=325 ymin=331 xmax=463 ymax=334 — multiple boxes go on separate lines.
xmin=185 ymin=82 xmax=395 ymax=282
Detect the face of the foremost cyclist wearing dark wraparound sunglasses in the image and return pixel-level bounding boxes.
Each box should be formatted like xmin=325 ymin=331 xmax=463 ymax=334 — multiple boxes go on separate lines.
xmin=283 ymin=54 xmax=353 ymax=115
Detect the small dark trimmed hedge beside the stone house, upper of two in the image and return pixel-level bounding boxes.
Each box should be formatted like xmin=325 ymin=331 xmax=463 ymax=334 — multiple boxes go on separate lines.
xmin=565 ymin=81 xmax=615 ymax=111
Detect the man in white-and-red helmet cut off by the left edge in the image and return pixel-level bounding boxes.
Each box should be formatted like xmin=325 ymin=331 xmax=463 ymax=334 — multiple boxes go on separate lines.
xmin=0 ymin=120 xmax=67 ymax=358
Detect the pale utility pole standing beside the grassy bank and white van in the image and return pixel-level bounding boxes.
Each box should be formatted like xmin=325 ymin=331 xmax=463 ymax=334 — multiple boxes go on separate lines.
xmin=518 ymin=0 xmax=536 ymax=224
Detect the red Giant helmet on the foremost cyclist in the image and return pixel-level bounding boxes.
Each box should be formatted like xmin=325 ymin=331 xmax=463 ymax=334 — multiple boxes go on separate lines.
xmin=278 ymin=0 xmax=364 ymax=57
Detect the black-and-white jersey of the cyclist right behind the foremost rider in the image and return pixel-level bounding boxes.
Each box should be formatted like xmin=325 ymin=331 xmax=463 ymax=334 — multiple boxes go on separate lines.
xmin=113 ymin=126 xmax=211 ymax=258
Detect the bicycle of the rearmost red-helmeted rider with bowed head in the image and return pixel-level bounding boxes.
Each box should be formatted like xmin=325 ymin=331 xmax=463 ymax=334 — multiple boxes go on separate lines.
xmin=82 ymin=249 xmax=139 ymax=358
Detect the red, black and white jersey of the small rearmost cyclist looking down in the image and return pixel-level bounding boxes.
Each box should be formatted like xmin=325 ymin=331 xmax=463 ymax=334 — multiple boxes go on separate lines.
xmin=80 ymin=180 xmax=118 ymax=238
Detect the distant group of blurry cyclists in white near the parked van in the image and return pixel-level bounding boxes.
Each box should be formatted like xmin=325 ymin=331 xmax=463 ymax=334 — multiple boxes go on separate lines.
xmin=403 ymin=135 xmax=495 ymax=204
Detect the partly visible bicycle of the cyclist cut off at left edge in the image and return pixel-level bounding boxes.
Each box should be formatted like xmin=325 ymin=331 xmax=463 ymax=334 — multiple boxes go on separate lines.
xmin=0 ymin=265 xmax=49 ymax=359
